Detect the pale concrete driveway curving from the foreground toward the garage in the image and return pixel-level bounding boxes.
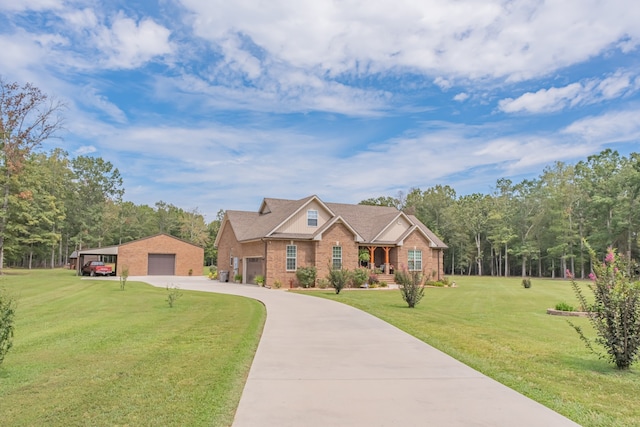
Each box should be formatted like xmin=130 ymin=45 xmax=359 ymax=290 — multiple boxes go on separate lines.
xmin=139 ymin=276 xmax=577 ymax=427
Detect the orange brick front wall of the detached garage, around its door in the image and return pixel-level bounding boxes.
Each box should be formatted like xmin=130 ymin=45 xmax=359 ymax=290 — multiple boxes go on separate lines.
xmin=116 ymin=235 xmax=204 ymax=276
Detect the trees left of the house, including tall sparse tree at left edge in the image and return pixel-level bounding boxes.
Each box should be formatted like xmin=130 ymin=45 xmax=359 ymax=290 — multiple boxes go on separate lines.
xmin=0 ymin=77 xmax=223 ymax=271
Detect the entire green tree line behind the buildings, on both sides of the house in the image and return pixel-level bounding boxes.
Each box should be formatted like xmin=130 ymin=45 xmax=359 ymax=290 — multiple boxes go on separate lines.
xmin=0 ymin=77 xmax=640 ymax=278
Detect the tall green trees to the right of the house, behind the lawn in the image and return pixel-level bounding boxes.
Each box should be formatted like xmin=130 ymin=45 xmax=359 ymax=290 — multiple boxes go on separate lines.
xmin=360 ymin=149 xmax=640 ymax=278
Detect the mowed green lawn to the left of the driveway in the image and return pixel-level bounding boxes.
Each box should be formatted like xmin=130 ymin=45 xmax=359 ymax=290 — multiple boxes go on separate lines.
xmin=0 ymin=270 xmax=266 ymax=426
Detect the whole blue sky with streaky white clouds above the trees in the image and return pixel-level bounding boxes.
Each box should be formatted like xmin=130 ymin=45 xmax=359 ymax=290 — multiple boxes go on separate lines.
xmin=0 ymin=0 xmax=640 ymax=221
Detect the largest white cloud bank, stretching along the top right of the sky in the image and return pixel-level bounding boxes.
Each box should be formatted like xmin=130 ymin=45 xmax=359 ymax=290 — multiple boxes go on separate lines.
xmin=181 ymin=0 xmax=640 ymax=80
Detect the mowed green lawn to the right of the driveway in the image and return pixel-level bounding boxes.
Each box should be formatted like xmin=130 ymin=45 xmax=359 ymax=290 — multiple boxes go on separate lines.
xmin=298 ymin=277 xmax=640 ymax=427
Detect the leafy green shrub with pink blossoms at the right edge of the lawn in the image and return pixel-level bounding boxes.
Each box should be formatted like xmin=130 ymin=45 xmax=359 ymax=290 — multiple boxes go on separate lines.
xmin=569 ymin=247 xmax=640 ymax=369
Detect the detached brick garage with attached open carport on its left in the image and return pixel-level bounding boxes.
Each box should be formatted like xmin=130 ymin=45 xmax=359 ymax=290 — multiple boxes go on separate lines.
xmin=78 ymin=234 xmax=204 ymax=276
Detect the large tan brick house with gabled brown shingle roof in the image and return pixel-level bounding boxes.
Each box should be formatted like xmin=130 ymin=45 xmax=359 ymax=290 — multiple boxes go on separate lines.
xmin=214 ymin=196 xmax=447 ymax=287
